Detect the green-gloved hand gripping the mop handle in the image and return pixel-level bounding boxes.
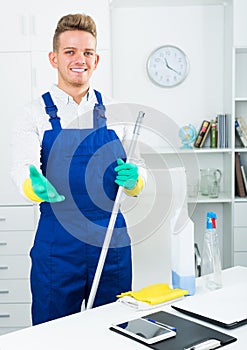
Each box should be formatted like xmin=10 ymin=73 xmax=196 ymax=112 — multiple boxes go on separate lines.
xmin=114 ymin=159 xmax=138 ymax=190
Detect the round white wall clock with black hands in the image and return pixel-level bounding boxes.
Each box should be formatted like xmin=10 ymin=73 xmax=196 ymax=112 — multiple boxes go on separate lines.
xmin=147 ymin=45 xmax=189 ymax=88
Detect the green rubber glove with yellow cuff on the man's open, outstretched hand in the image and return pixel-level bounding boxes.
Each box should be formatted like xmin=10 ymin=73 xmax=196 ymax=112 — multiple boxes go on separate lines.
xmin=23 ymin=165 xmax=65 ymax=203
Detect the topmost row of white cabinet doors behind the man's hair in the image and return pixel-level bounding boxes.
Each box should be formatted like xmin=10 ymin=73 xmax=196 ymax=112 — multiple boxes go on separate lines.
xmin=0 ymin=0 xmax=110 ymax=52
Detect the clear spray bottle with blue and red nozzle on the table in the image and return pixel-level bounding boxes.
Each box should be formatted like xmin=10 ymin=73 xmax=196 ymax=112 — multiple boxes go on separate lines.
xmin=202 ymin=212 xmax=222 ymax=290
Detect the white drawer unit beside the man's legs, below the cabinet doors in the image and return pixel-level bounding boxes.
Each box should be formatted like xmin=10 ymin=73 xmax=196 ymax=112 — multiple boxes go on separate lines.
xmin=0 ymin=206 xmax=35 ymax=334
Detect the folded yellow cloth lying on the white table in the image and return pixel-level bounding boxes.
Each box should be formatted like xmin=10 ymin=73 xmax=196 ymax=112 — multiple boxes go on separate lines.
xmin=117 ymin=283 xmax=189 ymax=305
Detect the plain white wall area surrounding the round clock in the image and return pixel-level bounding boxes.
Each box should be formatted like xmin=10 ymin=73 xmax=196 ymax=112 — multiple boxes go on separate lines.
xmin=112 ymin=5 xmax=224 ymax=127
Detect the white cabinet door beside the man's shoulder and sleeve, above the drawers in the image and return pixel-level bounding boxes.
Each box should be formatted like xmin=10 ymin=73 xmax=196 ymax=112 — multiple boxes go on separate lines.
xmin=0 ymin=53 xmax=31 ymax=205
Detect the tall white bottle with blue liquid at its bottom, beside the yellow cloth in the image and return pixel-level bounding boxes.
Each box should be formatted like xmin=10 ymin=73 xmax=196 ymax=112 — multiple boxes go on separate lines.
xmin=171 ymin=168 xmax=196 ymax=295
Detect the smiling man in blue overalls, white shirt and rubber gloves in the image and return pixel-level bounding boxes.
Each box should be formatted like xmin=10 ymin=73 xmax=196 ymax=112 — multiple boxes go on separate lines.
xmin=12 ymin=14 xmax=145 ymax=325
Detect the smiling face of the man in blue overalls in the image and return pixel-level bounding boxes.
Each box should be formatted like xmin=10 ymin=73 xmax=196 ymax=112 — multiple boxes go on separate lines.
xmin=49 ymin=30 xmax=99 ymax=90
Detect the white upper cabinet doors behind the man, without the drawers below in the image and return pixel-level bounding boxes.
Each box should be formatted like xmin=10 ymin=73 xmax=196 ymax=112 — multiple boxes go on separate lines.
xmin=0 ymin=0 xmax=111 ymax=205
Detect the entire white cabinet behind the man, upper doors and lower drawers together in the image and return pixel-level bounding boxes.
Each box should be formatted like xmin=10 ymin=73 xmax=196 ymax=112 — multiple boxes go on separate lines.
xmin=0 ymin=0 xmax=111 ymax=334
